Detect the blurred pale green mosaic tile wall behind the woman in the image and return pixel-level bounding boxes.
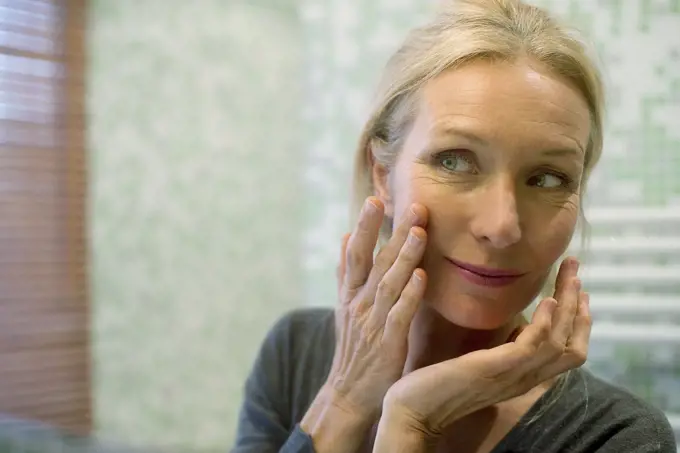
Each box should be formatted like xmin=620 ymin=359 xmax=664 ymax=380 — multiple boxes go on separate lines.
xmin=88 ymin=0 xmax=680 ymax=450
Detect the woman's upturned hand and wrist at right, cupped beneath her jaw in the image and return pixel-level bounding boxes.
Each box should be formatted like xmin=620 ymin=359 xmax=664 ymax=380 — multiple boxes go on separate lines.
xmin=378 ymin=258 xmax=591 ymax=439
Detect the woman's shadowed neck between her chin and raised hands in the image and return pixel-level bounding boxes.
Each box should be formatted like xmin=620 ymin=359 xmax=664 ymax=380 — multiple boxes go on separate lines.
xmin=404 ymin=304 xmax=526 ymax=375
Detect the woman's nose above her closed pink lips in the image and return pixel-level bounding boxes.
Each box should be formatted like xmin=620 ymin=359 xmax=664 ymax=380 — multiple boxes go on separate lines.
xmin=470 ymin=179 xmax=522 ymax=249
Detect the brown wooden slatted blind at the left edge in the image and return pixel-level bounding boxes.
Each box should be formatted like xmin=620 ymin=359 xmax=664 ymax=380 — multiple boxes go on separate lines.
xmin=0 ymin=0 xmax=91 ymax=433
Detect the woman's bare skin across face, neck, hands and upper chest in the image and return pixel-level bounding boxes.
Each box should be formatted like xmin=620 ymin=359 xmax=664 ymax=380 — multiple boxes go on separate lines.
xmin=301 ymin=60 xmax=590 ymax=453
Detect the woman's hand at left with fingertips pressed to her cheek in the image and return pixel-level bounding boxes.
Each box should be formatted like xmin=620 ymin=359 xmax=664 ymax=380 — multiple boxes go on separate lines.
xmin=324 ymin=197 xmax=427 ymax=417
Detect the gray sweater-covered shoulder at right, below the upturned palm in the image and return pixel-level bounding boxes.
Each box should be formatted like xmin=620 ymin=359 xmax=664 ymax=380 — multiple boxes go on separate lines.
xmin=515 ymin=370 xmax=677 ymax=453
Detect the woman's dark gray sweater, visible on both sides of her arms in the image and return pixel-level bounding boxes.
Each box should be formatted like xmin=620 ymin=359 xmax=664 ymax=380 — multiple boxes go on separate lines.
xmin=232 ymin=309 xmax=677 ymax=453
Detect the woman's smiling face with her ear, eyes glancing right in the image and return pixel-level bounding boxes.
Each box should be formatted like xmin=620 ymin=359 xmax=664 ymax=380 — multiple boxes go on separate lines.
xmin=374 ymin=62 xmax=590 ymax=329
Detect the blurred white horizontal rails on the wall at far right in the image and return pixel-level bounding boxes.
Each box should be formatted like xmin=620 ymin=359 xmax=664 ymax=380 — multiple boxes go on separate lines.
xmin=573 ymin=204 xmax=680 ymax=441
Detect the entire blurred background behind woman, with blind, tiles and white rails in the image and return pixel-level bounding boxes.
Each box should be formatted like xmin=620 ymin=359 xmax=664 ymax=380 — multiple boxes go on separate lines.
xmin=0 ymin=0 xmax=680 ymax=452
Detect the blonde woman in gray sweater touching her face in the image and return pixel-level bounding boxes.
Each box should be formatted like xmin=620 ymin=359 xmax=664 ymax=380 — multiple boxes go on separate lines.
xmin=234 ymin=0 xmax=676 ymax=453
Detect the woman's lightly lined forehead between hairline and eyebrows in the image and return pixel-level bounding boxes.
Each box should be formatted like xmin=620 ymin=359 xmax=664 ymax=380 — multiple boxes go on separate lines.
xmin=416 ymin=62 xmax=590 ymax=150
